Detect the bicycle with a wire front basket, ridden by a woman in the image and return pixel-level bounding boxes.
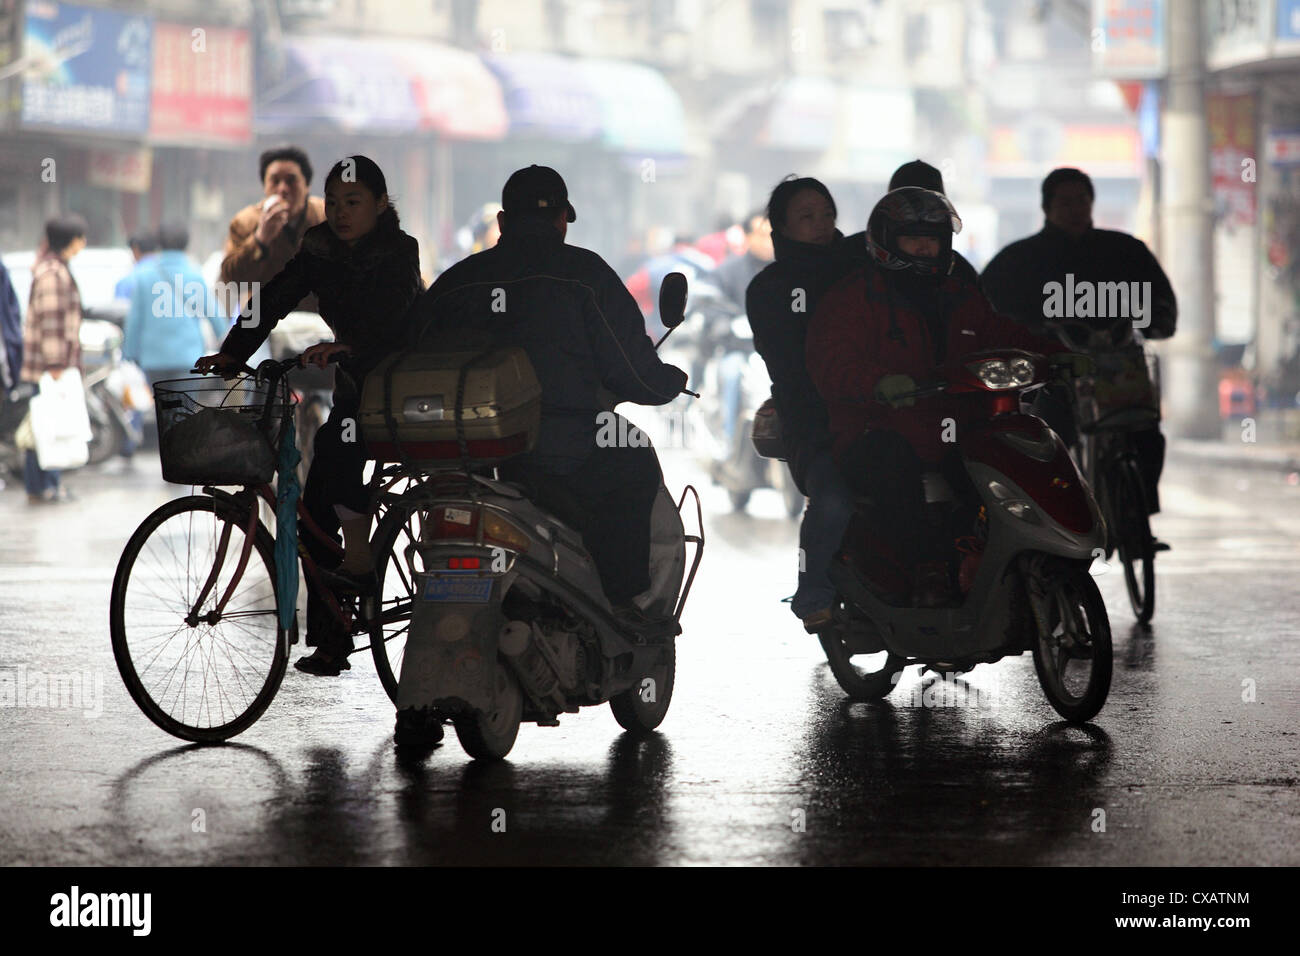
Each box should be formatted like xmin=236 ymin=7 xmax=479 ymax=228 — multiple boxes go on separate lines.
xmin=109 ymin=358 xmax=412 ymax=743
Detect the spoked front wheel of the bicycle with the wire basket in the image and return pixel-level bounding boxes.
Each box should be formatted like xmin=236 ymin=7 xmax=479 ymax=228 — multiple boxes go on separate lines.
xmin=109 ymin=494 xmax=291 ymax=743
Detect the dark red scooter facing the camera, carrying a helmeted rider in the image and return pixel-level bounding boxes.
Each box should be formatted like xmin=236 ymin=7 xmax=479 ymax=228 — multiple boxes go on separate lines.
xmin=764 ymin=349 xmax=1113 ymax=723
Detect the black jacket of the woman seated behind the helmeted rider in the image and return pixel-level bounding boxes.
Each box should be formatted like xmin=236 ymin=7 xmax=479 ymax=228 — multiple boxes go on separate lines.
xmin=745 ymin=230 xmax=866 ymax=490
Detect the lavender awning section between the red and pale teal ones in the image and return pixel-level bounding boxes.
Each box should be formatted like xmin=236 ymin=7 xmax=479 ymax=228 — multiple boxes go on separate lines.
xmin=484 ymin=53 xmax=603 ymax=142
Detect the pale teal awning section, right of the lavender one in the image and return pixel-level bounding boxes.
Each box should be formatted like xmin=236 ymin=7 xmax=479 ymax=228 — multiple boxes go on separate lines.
xmin=577 ymin=60 xmax=686 ymax=157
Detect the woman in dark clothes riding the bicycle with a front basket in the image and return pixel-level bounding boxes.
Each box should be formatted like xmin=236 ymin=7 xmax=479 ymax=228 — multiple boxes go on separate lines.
xmin=198 ymin=156 xmax=421 ymax=675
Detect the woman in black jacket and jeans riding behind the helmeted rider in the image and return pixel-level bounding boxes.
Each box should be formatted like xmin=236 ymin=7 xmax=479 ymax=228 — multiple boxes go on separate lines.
xmin=745 ymin=177 xmax=866 ymax=633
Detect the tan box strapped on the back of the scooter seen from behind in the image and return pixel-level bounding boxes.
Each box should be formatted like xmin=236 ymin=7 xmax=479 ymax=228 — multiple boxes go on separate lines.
xmin=359 ymin=346 xmax=542 ymax=463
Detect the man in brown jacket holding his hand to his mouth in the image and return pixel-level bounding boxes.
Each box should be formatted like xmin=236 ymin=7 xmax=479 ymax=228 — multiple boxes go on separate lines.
xmin=221 ymin=146 xmax=325 ymax=315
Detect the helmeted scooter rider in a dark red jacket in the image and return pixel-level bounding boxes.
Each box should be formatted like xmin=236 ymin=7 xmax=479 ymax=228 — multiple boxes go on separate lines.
xmin=807 ymin=186 xmax=1063 ymax=607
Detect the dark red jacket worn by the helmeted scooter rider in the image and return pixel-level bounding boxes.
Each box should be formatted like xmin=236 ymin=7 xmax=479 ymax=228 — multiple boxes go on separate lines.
xmin=807 ymin=263 xmax=1065 ymax=462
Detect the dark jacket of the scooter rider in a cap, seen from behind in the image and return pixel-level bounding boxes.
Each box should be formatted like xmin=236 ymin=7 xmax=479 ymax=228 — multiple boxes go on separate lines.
xmin=412 ymin=219 xmax=686 ymax=475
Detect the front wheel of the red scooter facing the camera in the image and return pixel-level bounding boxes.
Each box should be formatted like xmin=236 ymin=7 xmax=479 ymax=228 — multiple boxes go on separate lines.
xmin=1034 ymin=568 xmax=1113 ymax=723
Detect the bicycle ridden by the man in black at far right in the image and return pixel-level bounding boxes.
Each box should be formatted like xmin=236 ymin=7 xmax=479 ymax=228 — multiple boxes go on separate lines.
xmin=1047 ymin=320 xmax=1160 ymax=624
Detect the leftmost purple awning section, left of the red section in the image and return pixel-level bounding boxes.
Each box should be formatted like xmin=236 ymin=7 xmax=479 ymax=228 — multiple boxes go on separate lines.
xmin=256 ymin=36 xmax=420 ymax=133
